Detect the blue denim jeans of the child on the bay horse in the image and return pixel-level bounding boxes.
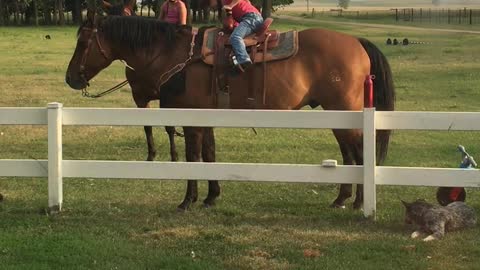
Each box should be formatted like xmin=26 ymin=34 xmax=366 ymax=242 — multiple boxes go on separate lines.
xmin=230 ymin=12 xmax=263 ymax=64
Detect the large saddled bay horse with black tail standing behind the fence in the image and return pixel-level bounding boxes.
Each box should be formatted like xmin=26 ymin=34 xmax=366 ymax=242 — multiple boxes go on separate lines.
xmin=65 ymin=16 xmax=395 ymax=210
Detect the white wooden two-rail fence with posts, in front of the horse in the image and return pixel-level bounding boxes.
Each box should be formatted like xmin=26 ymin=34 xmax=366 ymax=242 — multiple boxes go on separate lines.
xmin=0 ymin=103 xmax=480 ymax=217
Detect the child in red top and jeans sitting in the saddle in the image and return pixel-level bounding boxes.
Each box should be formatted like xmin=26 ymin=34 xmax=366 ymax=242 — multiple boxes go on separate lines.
xmin=223 ymin=0 xmax=263 ymax=72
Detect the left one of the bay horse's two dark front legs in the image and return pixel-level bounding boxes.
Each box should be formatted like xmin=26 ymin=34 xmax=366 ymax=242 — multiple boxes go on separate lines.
xmin=177 ymin=127 xmax=203 ymax=211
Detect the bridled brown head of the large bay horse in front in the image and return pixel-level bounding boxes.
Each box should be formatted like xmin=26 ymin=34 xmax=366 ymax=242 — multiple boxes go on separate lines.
xmin=65 ymin=11 xmax=114 ymax=90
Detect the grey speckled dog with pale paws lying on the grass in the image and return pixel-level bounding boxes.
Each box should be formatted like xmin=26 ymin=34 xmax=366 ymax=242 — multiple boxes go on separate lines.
xmin=402 ymin=200 xmax=477 ymax=241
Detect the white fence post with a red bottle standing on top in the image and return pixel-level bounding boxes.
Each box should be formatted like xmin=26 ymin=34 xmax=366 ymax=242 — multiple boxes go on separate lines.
xmin=363 ymin=108 xmax=377 ymax=220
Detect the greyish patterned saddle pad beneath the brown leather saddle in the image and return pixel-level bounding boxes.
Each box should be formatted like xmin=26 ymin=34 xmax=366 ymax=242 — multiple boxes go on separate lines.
xmin=202 ymin=28 xmax=298 ymax=65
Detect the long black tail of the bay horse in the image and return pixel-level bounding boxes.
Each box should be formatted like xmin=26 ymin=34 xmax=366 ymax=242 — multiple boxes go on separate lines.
xmin=358 ymin=38 xmax=395 ymax=165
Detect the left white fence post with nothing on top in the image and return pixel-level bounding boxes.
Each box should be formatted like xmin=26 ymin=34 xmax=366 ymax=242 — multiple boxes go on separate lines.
xmin=47 ymin=102 xmax=63 ymax=213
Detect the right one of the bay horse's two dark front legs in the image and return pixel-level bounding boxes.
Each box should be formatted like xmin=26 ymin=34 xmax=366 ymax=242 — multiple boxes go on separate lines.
xmin=202 ymin=128 xmax=220 ymax=208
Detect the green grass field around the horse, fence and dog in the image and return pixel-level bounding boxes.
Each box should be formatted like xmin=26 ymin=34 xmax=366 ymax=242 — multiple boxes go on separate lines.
xmin=0 ymin=16 xmax=480 ymax=269
